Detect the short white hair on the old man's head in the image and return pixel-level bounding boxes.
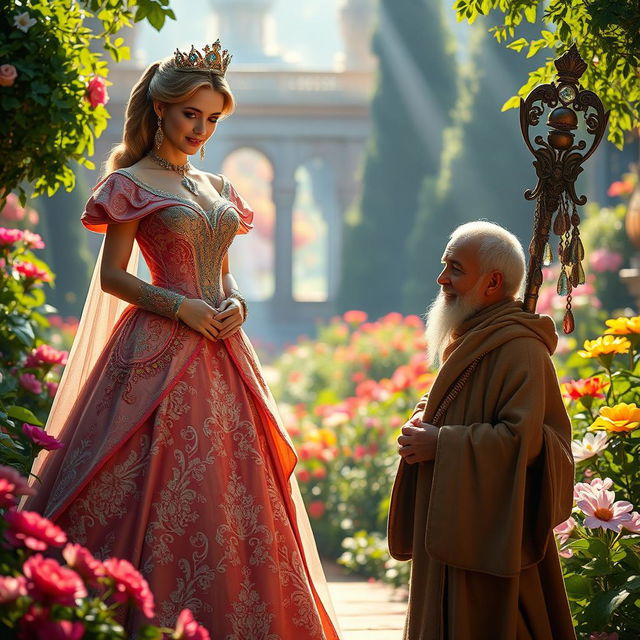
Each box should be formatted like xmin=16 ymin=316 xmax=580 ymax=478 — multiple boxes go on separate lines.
xmin=449 ymin=220 xmax=525 ymax=298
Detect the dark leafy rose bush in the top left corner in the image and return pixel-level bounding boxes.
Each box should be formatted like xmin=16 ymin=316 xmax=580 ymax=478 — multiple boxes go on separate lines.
xmin=0 ymin=0 xmax=175 ymax=205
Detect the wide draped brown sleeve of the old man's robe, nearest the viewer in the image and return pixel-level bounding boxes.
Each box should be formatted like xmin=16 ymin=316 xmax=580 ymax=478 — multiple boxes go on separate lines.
xmin=425 ymin=338 xmax=574 ymax=577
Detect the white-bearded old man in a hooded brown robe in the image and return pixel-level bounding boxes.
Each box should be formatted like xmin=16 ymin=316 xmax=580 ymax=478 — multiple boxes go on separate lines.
xmin=389 ymin=222 xmax=575 ymax=640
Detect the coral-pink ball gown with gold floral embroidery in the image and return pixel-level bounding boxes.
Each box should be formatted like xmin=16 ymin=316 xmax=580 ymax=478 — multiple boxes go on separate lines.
xmin=26 ymin=169 xmax=339 ymax=640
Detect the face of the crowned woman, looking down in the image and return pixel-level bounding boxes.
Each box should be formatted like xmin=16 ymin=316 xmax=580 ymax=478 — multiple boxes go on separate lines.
xmin=156 ymin=87 xmax=224 ymax=155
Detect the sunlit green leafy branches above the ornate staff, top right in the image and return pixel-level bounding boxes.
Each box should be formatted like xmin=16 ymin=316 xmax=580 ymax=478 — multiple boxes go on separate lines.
xmin=454 ymin=0 xmax=640 ymax=148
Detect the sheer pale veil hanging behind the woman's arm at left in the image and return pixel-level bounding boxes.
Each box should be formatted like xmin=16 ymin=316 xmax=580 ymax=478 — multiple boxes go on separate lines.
xmin=32 ymin=239 xmax=140 ymax=476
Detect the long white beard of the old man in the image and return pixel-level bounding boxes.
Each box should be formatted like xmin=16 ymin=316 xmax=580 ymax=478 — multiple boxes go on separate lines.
xmin=425 ymin=283 xmax=482 ymax=367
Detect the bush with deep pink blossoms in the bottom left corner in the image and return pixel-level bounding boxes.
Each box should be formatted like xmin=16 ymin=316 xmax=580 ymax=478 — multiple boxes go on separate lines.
xmin=0 ymin=465 xmax=210 ymax=640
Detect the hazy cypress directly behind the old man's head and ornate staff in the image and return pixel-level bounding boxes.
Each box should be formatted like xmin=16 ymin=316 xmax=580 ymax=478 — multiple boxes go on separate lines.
xmin=403 ymin=24 xmax=535 ymax=313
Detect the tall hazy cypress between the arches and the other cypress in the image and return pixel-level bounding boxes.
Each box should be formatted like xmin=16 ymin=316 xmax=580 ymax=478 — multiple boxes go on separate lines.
xmin=339 ymin=0 xmax=456 ymax=316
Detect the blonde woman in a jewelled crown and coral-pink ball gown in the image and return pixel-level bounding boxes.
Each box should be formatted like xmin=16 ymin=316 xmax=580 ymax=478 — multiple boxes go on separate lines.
xmin=27 ymin=42 xmax=338 ymax=640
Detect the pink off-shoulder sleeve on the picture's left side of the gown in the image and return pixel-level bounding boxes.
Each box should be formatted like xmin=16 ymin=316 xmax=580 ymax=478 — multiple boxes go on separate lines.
xmin=80 ymin=171 xmax=165 ymax=233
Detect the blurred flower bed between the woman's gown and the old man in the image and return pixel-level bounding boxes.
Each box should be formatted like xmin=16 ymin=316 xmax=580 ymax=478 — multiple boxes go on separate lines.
xmin=271 ymin=311 xmax=433 ymax=584
